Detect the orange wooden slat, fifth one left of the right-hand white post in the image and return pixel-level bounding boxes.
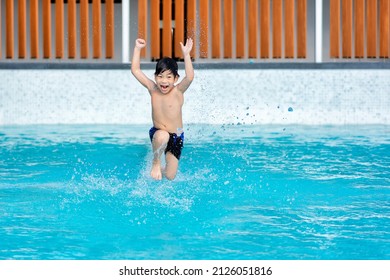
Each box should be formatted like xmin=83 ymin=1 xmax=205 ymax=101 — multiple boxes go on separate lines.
xmin=248 ymin=0 xmax=259 ymax=58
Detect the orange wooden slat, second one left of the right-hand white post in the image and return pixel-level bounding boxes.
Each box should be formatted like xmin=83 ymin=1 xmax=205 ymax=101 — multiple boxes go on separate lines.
xmin=284 ymin=0 xmax=295 ymax=58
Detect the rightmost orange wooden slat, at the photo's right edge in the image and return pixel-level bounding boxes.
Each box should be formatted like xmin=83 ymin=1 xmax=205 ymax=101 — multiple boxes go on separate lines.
xmin=379 ymin=0 xmax=389 ymax=58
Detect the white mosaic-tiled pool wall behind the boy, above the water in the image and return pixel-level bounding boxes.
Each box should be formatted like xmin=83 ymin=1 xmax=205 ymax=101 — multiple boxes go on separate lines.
xmin=0 ymin=69 xmax=390 ymax=125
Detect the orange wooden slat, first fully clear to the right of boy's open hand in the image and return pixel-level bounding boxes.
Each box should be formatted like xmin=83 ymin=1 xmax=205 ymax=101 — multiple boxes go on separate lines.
xmin=199 ymin=0 xmax=209 ymax=58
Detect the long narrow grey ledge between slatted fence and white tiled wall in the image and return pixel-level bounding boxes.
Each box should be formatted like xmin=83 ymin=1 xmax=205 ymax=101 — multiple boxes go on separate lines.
xmin=0 ymin=62 xmax=390 ymax=70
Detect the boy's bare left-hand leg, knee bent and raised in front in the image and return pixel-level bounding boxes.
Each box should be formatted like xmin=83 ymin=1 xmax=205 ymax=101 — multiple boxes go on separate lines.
xmin=150 ymin=130 xmax=169 ymax=180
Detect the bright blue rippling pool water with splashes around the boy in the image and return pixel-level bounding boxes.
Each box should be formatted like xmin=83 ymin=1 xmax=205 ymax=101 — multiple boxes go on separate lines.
xmin=0 ymin=125 xmax=390 ymax=260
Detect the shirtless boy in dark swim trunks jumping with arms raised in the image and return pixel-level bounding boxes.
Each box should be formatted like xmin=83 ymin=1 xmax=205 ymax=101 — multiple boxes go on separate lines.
xmin=131 ymin=39 xmax=194 ymax=180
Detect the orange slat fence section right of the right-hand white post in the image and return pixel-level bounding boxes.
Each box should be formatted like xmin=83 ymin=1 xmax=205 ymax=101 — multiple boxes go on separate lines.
xmin=329 ymin=0 xmax=390 ymax=59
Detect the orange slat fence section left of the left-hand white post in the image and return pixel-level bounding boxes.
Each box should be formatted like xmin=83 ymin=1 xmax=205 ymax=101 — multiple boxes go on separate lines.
xmin=0 ymin=0 xmax=116 ymax=59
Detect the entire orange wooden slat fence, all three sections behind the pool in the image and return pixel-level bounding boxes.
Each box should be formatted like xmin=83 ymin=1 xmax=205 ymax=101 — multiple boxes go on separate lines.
xmin=0 ymin=0 xmax=390 ymax=62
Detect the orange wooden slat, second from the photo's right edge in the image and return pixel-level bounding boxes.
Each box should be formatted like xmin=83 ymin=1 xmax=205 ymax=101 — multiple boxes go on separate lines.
xmin=366 ymin=0 xmax=377 ymax=58
